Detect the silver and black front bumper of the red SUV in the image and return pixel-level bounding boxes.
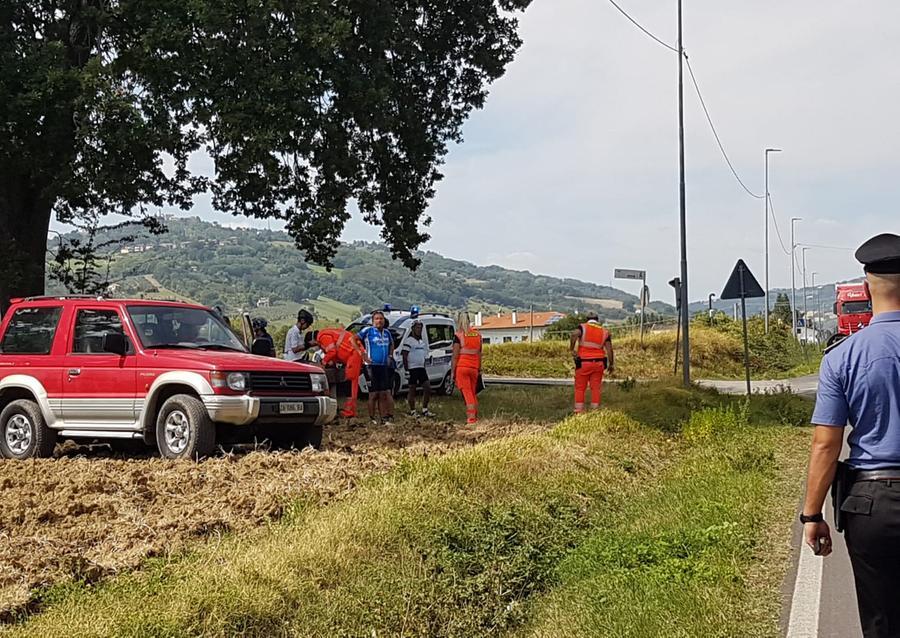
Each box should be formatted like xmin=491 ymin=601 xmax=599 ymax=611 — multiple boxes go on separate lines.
xmin=202 ymin=394 xmax=337 ymax=425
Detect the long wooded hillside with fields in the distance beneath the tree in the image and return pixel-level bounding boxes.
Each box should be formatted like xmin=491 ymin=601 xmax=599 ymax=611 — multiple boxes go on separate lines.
xmin=48 ymin=217 xmax=673 ymax=328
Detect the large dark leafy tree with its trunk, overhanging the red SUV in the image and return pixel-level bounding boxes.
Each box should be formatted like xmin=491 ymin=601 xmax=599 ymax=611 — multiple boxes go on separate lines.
xmin=0 ymin=0 xmax=530 ymax=308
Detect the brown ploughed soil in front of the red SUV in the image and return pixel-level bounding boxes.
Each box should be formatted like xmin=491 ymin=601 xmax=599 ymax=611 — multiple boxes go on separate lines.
xmin=0 ymin=421 xmax=542 ymax=619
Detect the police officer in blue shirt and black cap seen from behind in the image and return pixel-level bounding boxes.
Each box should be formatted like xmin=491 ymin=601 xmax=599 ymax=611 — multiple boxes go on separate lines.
xmin=800 ymin=234 xmax=900 ymax=638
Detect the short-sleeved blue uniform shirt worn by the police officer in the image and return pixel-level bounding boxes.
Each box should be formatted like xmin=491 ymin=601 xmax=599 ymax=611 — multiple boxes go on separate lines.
xmin=812 ymin=312 xmax=900 ymax=470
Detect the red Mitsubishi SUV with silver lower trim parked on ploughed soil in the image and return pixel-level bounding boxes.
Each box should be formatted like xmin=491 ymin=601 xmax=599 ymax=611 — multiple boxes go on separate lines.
xmin=0 ymin=297 xmax=337 ymax=459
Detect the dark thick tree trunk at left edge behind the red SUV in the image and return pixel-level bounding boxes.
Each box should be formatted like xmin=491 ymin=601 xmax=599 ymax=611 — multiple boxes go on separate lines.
xmin=0 ymin=173 xmax=52 ymax=313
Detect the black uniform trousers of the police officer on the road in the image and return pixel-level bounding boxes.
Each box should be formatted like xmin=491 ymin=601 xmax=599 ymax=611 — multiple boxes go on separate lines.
xmin=841 ymin=481 xmax=900 ymax=638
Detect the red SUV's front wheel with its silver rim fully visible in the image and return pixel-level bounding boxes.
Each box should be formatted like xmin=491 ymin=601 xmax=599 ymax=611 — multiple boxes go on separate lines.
xmin=156 ymin=394 xmax=216 ymax=459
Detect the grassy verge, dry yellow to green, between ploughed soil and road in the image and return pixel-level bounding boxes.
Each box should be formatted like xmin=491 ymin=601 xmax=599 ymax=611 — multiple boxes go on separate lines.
xmin=1 ymin=386 xmax=809 ymax=638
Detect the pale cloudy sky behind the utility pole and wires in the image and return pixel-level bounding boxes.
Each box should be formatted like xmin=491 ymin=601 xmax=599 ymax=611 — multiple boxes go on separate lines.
xmin=110 ymin=0 xmax=900 ymax=308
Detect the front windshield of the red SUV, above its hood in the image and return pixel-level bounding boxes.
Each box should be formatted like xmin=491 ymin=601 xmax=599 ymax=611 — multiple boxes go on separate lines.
xmin=128 ymin=306 xmax=247 ymax=352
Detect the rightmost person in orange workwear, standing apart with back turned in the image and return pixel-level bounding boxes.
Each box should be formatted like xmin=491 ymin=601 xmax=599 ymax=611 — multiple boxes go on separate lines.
xmin=569 ymin=312 xmax=615 ymax=414
